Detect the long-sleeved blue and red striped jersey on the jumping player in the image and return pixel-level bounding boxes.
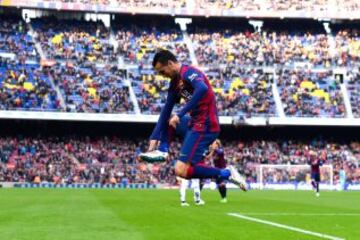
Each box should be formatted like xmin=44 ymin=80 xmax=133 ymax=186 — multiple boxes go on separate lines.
xmin=150 ymin=65 xmax=220 ymax=140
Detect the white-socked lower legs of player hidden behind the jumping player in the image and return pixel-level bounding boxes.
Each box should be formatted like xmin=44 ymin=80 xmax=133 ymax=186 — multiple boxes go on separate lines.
xmin=177 ymin=177 xmax=205 ymax=207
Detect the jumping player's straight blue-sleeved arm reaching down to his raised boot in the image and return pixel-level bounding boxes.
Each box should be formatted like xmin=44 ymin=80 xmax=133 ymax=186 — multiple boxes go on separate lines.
xmin=150 ymin=91 xmax=176 ymax=145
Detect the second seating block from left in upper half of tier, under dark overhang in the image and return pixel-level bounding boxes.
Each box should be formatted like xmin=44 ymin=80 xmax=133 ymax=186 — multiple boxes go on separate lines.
xmin=32 ymin=17 xmax=117 ymax=64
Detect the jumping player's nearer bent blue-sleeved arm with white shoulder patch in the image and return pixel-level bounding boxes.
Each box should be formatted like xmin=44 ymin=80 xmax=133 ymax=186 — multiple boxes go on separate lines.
xmin=177 ymin=71 xmax=208 ymax=118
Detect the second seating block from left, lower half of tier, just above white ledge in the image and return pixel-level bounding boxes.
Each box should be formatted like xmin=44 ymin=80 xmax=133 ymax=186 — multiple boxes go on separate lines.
xmin=51 ymin=64 xmax=134 ymax=113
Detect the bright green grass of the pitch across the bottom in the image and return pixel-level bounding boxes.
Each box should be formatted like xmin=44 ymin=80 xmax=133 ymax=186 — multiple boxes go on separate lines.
xmin=0 ymin=189 xmax=360 ymax=240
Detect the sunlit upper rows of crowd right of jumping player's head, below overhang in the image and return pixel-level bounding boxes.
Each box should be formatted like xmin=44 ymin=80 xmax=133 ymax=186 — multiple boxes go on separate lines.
xmin=190 ymin=29 xmax=360 ymax=68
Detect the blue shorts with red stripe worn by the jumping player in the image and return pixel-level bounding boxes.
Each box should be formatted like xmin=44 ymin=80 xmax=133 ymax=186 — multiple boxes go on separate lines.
xmin=176 ymin=116 xmax=219 ymax=165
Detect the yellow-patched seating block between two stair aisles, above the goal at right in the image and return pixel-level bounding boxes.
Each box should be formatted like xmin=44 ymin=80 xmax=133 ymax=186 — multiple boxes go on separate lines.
xmin=277 ymin=68 xmax=346 ymax=118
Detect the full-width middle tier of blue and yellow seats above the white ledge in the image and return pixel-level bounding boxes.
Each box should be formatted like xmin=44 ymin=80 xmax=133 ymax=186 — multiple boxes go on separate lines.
xmin=0 ymin=11 xmax=360 ymax=124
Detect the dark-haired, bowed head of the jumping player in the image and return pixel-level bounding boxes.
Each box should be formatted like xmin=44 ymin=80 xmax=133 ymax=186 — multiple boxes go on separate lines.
xmin=152 ymin=49 xmax=181 ymax=78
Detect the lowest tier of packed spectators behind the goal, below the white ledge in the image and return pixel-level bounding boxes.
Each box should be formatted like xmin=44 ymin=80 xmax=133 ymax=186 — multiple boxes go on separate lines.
xmin=0 ymin=136 xmax=360 ymax=184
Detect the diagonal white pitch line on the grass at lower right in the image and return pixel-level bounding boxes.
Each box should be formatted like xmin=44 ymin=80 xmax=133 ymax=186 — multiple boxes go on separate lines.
xmin=228 ymin=213 xmax=345 ymax=240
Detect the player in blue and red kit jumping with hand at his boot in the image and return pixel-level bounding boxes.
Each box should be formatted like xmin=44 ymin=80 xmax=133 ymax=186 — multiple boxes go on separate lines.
xmin=140 ymin=50 xmax=246 ymax=191
